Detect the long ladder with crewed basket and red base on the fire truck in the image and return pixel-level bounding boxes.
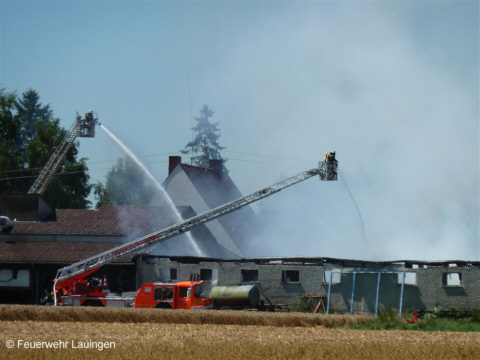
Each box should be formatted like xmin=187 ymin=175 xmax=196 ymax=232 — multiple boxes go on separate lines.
xmin=54 ymin=152 xmax=338 ymax=305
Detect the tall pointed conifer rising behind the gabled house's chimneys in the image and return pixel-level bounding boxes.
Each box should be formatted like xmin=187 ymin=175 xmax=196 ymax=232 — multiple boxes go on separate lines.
xmin=180 ymin=105 xmax=226 ymax=167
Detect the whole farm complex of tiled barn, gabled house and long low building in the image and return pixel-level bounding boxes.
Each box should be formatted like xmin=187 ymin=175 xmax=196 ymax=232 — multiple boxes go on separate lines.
xmin=0 ymin=157 xmax=480 ymax=313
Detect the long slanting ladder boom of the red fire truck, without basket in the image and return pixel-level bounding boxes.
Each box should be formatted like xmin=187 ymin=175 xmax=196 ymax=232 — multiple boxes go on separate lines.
xmin=55 ymin=168 xmax=321 ymax=283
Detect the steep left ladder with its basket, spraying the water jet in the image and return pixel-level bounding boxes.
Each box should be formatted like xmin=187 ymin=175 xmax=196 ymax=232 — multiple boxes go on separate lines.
xmin=28 ymin=110 xmax=98 ymax=195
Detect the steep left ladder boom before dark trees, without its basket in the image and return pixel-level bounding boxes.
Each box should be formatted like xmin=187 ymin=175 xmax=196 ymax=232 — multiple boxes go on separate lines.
xmin=28 ymin=120 xmax=78 ymax=195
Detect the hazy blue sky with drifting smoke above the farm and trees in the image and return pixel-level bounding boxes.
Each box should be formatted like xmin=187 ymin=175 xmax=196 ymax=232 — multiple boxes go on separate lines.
xmin=0 ymin=0 xmax=480 ymax=260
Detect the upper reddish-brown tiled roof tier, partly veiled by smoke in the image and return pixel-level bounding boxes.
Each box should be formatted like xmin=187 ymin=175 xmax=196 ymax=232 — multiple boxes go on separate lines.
xmin=10 ymin=205 xmax=191 ymax=236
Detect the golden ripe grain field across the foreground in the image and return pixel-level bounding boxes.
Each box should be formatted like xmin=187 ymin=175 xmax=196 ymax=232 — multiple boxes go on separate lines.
xmin=0 ymin=305 xmax=480 ymax=360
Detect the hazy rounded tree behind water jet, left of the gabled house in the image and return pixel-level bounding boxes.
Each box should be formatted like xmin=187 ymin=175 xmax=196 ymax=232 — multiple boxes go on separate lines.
xmin=93 ymin=156 xmax=155 ymax=209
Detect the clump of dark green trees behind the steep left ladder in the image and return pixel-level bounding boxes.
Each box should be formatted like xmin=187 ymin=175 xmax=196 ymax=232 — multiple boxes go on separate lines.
xmin=0 ymin=89 xmax=91 ymax=209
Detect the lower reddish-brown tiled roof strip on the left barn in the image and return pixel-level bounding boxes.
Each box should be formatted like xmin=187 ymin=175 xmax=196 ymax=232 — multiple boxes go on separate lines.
xmin=0 ymin=241 xmax=135 ymax=263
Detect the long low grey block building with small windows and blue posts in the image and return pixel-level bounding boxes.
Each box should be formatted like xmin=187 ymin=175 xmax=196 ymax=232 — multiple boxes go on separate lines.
xmin=137 ymin=255 xmax=480 ymax=313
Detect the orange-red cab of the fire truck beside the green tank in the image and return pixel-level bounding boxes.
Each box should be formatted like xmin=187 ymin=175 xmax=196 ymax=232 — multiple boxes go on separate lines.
xmin=134 ymin=281 xmax=212 ymax=310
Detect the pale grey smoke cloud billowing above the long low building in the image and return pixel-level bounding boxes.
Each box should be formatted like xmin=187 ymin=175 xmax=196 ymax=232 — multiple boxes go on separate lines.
xmin=211 ymin=5 xmax=479 ymax=260
